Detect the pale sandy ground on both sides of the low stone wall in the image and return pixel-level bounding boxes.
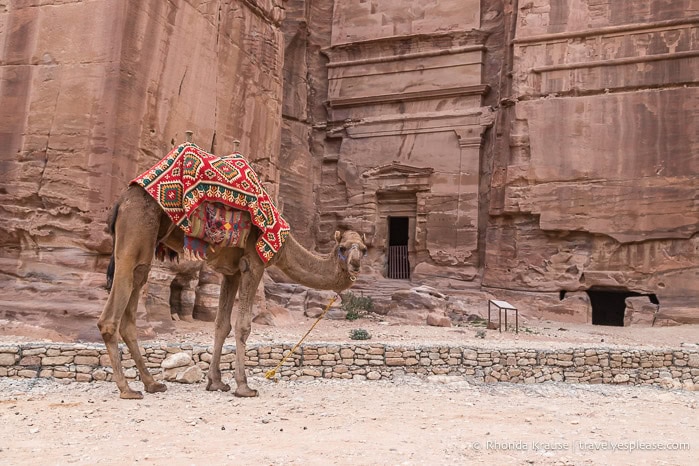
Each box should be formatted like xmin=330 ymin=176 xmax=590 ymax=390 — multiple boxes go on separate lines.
xmin=0 ymin=319 xmax=699 ymax=465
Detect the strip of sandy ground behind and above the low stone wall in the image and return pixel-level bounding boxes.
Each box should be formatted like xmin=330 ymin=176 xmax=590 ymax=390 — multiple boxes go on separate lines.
xmin=0 ymin=312 xmax=699 ymax=349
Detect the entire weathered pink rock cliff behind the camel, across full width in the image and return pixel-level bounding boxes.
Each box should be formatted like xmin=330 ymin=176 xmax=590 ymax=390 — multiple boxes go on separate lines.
xmin=0 ymin=0 xmax=699 ymax=340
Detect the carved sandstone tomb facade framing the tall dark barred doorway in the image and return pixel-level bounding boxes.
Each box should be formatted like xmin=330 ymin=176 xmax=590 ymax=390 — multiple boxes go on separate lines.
xmin=319 ymin=1 xmax=493 ymax=278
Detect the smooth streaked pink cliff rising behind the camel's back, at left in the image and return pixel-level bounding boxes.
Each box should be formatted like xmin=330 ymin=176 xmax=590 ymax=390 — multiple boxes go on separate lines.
xmin=0 ymin=0 xmax=284 ymax=332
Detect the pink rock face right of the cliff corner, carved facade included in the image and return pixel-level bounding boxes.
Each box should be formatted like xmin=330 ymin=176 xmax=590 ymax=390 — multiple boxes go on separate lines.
xmin=281 ymin=0 xmax=699 ymax=322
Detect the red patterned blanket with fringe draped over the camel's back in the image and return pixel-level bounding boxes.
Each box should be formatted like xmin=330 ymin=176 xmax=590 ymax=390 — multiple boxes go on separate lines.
xmin=131 ymin=143 xmax=290 ymax=262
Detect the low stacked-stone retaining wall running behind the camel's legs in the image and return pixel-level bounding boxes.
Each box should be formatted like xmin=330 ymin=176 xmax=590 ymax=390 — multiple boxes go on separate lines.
xmin=0 ymin=343 xmax=699 ymax=389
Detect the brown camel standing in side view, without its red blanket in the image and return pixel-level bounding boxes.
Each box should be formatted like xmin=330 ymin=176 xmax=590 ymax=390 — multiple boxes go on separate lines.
xmin=97 ymin=185 xmax=367 ymax=399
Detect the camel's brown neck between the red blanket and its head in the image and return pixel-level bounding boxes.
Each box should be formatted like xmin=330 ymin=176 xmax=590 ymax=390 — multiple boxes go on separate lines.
xmin=274 ymin=235 xmax=353 ymax=293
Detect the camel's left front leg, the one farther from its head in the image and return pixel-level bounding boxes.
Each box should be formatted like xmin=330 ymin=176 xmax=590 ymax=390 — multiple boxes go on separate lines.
xmin=206 ymin=274 xmax=240 ymax=392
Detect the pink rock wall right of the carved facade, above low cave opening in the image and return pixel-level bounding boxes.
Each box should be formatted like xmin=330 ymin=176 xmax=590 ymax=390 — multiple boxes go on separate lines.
xmin=483 ymin=0 xmax=699 ymax=321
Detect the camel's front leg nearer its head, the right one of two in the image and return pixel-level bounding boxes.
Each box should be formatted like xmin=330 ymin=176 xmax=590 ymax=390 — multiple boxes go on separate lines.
xmin=235 ymin=253 xmax=265 ymax=397
